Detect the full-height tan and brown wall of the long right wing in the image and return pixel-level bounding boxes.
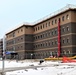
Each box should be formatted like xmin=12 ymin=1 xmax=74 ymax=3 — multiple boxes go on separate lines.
xmin=34 ymin=11 xmax=76 ymax=58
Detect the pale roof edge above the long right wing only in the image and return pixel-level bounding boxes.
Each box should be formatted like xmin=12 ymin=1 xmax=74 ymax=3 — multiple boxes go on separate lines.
xmin=34 ymin=4 xmax=76 ymax=26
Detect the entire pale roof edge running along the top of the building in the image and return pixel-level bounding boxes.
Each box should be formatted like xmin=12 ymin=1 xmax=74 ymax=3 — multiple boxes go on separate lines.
xmin=6 ymin=4 xmax=76 ymax=34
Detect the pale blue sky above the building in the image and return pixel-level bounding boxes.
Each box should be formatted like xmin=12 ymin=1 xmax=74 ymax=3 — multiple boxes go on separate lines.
xmin=0 ymin=0 xmax=76 ymax=38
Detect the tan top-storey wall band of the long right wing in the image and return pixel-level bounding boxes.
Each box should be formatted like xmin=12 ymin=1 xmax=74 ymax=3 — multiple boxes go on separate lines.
xmin=34 ymin=11 xmax=72 ymax=34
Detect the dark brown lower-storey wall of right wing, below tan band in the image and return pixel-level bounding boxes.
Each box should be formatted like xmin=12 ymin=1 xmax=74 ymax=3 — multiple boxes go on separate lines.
xmin=34 ymin=23 xmax=72 ymax=57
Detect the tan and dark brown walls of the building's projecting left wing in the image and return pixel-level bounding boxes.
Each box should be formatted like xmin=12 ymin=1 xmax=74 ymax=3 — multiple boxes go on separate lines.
xmin=6 ymin=26 xmax=33 ymax=59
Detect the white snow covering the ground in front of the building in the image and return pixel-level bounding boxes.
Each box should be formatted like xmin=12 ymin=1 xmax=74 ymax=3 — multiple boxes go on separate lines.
xmin=0 ymin=60 xmax=76 ymax=75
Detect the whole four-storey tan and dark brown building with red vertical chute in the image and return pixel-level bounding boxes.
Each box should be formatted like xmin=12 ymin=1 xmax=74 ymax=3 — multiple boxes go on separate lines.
xmin=6 ymin=5 xmax=76 ymax=59
